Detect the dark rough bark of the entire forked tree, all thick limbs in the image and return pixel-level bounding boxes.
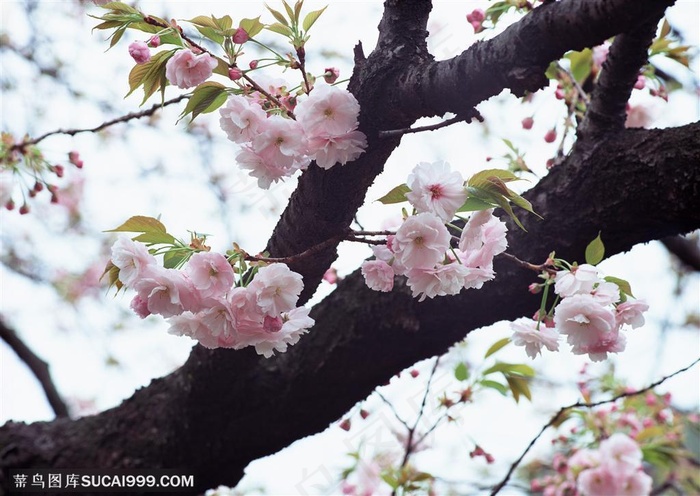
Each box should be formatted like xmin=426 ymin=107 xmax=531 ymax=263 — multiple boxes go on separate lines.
xmin=0 ymin=0 xmax=700 ymax=492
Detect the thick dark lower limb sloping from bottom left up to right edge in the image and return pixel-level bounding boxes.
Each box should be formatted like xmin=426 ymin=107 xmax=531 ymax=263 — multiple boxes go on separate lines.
xmin=0 ymin=123 xmax=700 ymax=490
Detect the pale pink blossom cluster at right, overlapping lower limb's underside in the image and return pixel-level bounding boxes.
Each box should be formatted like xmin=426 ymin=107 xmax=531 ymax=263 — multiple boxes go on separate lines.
xmin=512 ymin=264 xmax=649 ymax=362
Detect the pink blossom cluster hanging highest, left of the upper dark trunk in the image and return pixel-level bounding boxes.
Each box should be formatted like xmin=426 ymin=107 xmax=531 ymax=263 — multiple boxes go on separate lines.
xmin=219 ymin=85 xmax=367 ymax=189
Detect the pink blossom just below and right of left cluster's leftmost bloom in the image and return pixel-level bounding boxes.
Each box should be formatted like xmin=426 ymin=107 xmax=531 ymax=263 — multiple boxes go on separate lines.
xmin=134 ymin=265 xmax=200 ymax=318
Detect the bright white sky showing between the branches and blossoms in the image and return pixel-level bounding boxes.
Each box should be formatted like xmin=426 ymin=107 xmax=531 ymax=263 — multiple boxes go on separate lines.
xmin=0 ymin=0 xmax=700 ymax=494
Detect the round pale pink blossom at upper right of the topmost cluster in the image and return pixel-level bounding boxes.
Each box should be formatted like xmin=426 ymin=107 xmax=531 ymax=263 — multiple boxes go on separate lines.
xmin=295 ymin=85 xmax=360 ymax=136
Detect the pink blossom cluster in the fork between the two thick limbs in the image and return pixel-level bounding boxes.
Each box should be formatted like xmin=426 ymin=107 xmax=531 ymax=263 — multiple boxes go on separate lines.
xmin=362 ymin=162 xmax=507 ymax=301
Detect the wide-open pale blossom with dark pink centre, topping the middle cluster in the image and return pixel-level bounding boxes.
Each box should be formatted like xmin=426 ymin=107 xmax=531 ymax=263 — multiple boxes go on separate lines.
xmin=406 ymin=161 xmax=467 ymax=222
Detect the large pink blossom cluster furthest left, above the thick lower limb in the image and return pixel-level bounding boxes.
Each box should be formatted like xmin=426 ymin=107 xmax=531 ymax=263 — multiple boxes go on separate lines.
xmin=112 ymin=237 xmax=314 ymax=358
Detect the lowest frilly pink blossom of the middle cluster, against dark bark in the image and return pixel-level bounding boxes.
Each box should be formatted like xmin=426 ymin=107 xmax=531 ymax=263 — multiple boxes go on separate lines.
xmin=406 ymin=262 xmax=473 ymax=301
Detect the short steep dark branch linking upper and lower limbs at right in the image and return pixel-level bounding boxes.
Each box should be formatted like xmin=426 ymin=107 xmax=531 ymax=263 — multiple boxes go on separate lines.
xmin=577 ymin=16 xmax=660 ymax=148
